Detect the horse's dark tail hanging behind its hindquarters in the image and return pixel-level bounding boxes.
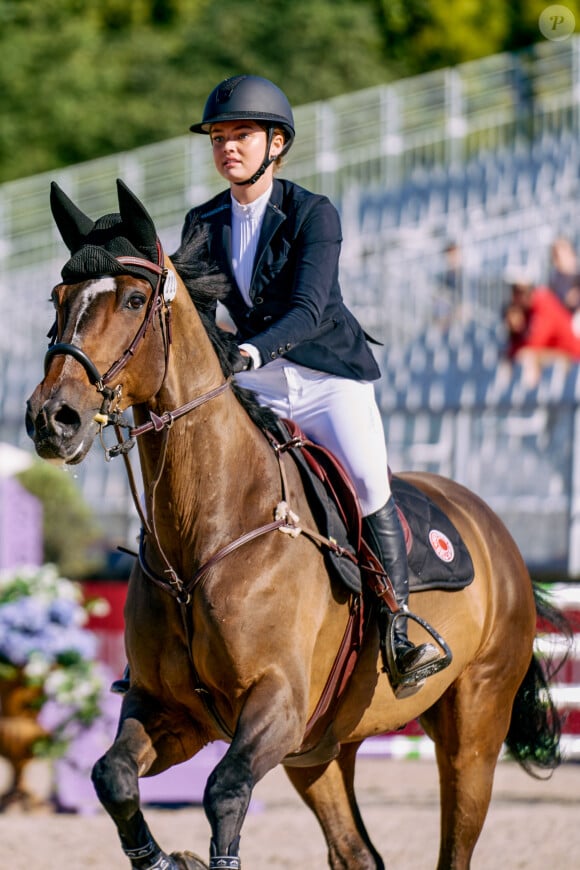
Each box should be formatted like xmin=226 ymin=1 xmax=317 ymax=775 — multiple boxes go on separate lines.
xmin=505 ymin=583 xmax=573 ymax=779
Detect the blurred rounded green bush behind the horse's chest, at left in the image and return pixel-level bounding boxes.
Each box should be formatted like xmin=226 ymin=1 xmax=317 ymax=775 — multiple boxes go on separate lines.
xmin=17 ymin=461 xmax=101 ymax=578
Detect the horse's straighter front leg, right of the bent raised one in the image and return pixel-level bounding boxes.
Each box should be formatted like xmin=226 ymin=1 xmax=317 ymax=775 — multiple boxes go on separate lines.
xmin=203 ymin=677 xmax=301 ymax=870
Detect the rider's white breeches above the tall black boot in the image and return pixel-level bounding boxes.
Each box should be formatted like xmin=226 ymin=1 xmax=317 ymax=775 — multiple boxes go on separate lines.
xmin=236 ymin=359 xmax=391 ymax=516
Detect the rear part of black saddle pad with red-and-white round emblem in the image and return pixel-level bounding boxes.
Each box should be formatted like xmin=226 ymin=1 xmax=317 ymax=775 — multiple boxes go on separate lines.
xmin=391 ymin=476 xmax=473 ymax=592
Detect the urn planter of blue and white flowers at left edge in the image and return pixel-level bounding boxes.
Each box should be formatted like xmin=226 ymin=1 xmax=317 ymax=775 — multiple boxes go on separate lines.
xmin=0 ymin=565 xmax=106 ymax=811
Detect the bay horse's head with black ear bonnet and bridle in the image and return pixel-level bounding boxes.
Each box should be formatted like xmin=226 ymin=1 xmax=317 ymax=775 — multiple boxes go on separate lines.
xmin=26 ymin=181 xmax=193 ymax=464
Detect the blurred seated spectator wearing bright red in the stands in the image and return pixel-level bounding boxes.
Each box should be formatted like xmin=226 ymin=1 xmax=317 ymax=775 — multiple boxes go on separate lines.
xmin=504 ymin=270 xmax=580 ymax=384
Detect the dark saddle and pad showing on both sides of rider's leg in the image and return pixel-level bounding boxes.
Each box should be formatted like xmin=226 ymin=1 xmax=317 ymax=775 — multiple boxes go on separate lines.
xmin=279 ymin=420 xmax=474 ymax=594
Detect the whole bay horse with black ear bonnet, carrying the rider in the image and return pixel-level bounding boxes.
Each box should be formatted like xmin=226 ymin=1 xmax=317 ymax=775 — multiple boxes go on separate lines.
xmin=26 ymin=181 xmax=560 ymax=870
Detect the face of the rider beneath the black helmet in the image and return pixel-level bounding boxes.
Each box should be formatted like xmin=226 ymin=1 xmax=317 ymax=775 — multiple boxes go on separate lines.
xmin=210 ymin=121 xmax=284 ymax=183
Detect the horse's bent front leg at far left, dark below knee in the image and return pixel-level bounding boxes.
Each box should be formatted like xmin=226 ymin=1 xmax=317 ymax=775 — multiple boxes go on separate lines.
xmin=92 ymin=718 xmax=207 ymax=870
